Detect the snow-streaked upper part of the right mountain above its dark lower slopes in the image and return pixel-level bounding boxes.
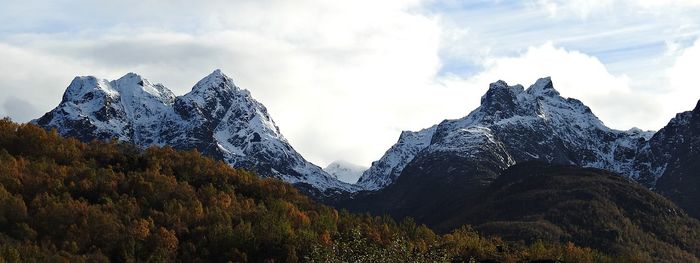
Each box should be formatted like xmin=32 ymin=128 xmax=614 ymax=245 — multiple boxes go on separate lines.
xmin=358 ymin=78 xmax=663 ymax=190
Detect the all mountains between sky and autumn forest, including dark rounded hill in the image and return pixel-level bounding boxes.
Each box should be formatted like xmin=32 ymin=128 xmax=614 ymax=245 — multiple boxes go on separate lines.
xmin=23 ymin=70 xmax=700 ymax=262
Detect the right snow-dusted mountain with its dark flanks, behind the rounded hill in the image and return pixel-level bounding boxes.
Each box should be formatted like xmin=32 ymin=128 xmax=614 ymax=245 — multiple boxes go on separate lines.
xmin=350 ymin=78 xmax=700 ymax=223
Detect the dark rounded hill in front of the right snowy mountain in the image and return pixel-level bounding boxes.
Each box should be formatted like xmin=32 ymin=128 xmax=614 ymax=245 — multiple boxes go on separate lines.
xmin=437 ymin=162 xmax=700 ymax=262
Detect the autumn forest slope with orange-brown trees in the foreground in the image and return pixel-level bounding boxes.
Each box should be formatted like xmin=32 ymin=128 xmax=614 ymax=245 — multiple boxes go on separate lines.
xmin=0 ymin=119 xmax=637 ymax=262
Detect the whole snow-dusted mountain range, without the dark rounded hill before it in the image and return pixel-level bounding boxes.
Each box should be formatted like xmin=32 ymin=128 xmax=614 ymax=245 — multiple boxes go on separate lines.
xmin=32 ymin=70 xmax=700 ymax=223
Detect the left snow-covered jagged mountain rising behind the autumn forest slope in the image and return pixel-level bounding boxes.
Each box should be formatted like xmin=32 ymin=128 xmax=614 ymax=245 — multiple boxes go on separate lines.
xmin=33 ymin=70 xmax=357 ymax=196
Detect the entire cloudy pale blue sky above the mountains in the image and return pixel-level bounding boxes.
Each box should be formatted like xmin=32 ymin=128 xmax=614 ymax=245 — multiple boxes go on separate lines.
xmin=0 ymin=0 xmax=700 ymax=166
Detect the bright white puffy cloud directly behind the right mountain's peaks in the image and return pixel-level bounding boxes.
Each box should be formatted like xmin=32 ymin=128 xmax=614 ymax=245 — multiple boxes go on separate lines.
xmin=442 ymin=43 xmax=668 ymax=132
